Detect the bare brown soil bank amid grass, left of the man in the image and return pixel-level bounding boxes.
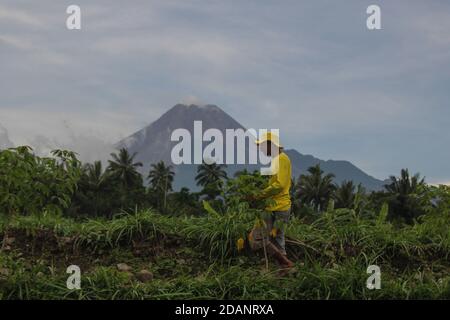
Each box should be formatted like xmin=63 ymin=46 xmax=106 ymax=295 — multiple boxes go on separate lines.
xmin=2 ymin=229 xmax=205 ymax=276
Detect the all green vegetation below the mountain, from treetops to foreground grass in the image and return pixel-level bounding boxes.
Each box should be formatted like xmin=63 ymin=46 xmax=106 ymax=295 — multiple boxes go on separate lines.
xmin=0 ymin=148 xmax=450 ymax=299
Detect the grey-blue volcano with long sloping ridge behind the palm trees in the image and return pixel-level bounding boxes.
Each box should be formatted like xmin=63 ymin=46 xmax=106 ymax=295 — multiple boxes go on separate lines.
xmin=115 ymin=103 xmax=384 ymax=190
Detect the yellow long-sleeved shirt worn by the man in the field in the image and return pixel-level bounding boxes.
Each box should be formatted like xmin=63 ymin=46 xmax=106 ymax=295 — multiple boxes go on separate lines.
xmin=262 ymin=152 xmax=291 ymax=211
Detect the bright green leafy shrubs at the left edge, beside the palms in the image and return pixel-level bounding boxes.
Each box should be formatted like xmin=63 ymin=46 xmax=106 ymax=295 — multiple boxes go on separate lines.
xmin=0 ymin=147 xmax=81 ymax=215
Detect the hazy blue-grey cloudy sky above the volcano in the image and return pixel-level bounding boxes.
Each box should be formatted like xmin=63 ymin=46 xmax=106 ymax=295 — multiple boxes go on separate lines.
xmin=0 ymin=0 xmax=450 ymax=182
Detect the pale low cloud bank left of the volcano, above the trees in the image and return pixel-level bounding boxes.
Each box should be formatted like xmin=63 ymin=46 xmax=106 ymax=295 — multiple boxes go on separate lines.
xmin=0 ymin=108 xmax=138 ymax=162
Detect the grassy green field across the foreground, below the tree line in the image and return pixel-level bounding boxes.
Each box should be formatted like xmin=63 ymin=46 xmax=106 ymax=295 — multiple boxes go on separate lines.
xmin=0 ymin=210 xmax=450 ymax=299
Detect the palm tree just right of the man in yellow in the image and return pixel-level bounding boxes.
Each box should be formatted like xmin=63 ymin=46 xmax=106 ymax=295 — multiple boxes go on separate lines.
xmin=296 ymin=164 xmax=336 ymax=211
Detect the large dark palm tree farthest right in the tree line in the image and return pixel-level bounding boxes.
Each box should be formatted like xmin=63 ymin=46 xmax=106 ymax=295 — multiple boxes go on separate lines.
xmin=384 ymin=169 xmax=425 ymax=222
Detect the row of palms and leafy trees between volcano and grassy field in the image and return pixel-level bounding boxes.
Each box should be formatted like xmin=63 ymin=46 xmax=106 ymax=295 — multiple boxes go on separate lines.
xmin=0 ymin=147 xmax=433 ymax=223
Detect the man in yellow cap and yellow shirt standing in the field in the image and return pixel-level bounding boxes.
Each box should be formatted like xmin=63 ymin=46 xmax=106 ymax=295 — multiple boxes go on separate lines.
xmin=251 ymin=132 xmax=294 ymax=268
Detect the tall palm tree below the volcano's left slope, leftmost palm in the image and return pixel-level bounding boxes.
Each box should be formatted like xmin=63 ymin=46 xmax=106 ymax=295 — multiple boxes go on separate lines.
xmin=108 ymin=148 xmax=142 ymax=189
